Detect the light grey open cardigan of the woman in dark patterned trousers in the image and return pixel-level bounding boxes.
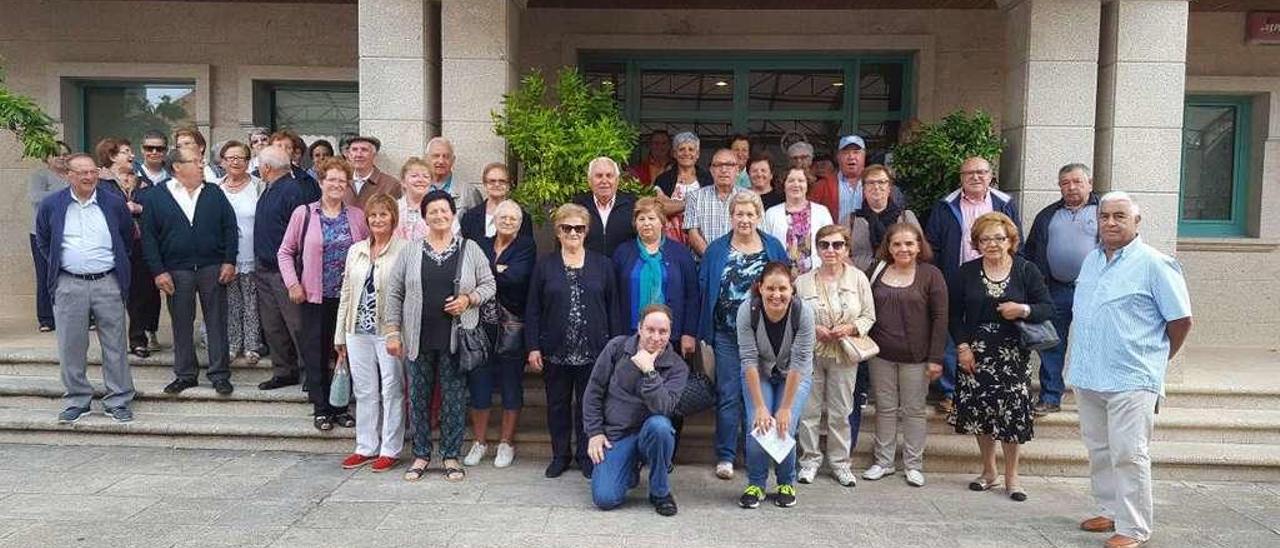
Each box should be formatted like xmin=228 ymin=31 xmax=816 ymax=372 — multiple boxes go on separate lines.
xmin=384 ymin=239 xmax=498 ymax=360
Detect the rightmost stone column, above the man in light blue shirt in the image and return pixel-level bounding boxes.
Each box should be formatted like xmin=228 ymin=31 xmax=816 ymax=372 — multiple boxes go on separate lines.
xmin=1094 ymin=0 xmax=1188 ymax=254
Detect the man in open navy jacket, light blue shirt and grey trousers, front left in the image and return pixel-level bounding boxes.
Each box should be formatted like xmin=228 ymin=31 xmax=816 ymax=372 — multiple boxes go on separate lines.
xmin=36 ymin=154 xmax=133 ymax=424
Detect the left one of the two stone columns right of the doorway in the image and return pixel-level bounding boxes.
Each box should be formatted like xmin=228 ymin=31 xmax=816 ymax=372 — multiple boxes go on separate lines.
xmin=1000 ymin=0 xmax=1101 ymax=229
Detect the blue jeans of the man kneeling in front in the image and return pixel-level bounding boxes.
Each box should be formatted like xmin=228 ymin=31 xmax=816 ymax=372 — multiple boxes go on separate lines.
xmin=591 ymin=415 xmax=676 ymax=510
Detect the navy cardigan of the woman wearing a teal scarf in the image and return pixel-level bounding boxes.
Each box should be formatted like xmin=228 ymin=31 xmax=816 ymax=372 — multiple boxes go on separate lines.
xmin=613 ymin=238 xmax=699 ymax=340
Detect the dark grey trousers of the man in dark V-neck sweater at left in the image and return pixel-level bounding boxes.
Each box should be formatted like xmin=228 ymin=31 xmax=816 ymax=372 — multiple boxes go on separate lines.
xmin=169 ymin=265 xmax=232 ymax=380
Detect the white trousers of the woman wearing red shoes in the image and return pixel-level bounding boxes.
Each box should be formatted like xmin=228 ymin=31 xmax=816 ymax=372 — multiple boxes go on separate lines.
xmin=347 ymin=333 xmax=404 ymax=458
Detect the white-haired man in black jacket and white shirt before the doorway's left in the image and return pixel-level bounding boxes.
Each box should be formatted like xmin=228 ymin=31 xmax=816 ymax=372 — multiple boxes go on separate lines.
xmin=573 ymin=156 xmax=636 ymax=257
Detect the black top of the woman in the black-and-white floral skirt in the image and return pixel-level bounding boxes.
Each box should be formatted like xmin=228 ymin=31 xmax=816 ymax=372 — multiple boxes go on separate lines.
xmin=948 ymin=255 xmax=1053 ymax=344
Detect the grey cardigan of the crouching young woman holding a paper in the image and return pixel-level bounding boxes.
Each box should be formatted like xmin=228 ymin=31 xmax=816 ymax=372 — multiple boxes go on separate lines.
xmin=737 ymin=298 xmax=817 ymax=382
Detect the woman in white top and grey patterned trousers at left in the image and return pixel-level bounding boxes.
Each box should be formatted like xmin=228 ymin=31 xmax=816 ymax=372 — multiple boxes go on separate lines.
xmin=218 ymin=141 xmax=262 ymax=364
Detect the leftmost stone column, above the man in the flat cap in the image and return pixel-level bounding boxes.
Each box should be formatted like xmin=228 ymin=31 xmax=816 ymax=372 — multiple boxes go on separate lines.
xmin=358 ymin=0 xmax=440 ymax=175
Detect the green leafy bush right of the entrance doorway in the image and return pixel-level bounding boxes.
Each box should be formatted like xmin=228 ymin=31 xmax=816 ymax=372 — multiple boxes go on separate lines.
xmin=893 ymin=110 xmax=1005 ymax=211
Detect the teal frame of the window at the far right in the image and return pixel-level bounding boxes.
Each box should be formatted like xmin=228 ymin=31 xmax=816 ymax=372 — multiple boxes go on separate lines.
xmin=1178 ymin=95 xmax=1253 ymax=238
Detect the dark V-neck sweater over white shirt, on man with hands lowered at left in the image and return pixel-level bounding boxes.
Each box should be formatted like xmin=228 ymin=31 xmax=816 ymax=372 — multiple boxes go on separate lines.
xmin=142 ymin=183 xmax=239 ymax=274
